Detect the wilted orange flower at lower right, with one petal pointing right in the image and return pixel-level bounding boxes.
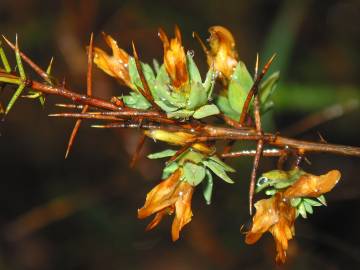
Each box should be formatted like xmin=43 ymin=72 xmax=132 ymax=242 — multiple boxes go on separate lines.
xmin=245 ymin=170 xmax=341 ymax=263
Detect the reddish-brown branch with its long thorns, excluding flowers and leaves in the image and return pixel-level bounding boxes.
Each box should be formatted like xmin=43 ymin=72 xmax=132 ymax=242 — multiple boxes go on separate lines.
xmin=0 ymin=36 xmax=360 ymax=213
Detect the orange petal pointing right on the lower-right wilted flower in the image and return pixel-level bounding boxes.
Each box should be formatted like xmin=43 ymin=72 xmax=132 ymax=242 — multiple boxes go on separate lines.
xmin=284 ymin=170 xmax=341 ymax=198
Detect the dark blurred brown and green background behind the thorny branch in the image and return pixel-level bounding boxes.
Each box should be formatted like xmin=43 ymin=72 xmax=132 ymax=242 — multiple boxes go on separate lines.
xmin=0 ymin=0 xmax=360 ymax=270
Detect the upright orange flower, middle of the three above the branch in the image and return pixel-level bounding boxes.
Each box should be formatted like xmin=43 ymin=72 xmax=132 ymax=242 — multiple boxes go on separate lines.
xmin=159 ymin=26 xmax=188 ymax=89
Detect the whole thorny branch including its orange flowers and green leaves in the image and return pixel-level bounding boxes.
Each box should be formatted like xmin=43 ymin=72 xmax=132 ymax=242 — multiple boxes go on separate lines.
xmin=0 ymin=26 xmax=360 ymax=262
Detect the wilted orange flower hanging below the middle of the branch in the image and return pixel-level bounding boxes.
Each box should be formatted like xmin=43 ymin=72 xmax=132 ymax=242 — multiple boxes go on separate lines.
xmin=138 ymin=169 xmax=194 ymax=241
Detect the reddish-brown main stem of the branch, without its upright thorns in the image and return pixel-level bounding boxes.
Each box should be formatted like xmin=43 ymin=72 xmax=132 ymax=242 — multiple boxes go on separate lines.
xmin=0 ymin=70 xmax=360 ymax=157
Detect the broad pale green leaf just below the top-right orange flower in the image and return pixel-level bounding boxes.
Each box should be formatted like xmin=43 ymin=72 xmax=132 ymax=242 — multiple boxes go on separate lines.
xmin=228 ymin=61 xmax=253 ymax=113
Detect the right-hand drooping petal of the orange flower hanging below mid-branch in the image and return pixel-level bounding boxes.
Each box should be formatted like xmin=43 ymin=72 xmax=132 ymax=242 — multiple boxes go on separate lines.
xmin=171 ymin=182 xmax=194 ymax=241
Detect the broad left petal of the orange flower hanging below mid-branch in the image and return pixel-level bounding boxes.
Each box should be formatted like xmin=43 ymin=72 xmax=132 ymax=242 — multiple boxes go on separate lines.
xmin=138 ymin=170 xmax=181 ymax=219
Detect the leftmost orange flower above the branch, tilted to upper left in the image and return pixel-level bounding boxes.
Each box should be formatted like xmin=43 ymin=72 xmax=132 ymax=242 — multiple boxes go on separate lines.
xmin=94 ymin=34 xmax=133 ymax=88
